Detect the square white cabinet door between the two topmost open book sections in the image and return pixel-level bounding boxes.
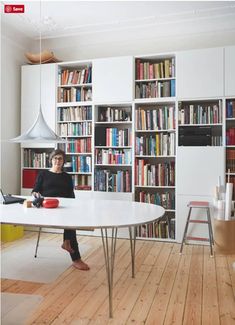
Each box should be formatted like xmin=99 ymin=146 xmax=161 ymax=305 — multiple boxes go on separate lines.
xmin=92 ymin=56 xmax=134 ymax=103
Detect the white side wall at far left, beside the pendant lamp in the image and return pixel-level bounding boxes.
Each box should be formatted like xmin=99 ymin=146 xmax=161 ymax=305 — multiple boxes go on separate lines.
xmin=0 ymin=25 xmax=31 ymax=194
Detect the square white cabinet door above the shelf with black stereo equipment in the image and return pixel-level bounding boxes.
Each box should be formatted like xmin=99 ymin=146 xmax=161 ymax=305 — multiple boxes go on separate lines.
xmin=176 ymin=48 xmax=224 ymax=99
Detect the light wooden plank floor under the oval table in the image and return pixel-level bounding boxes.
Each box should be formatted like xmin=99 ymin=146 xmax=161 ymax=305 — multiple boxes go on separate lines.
xmin=1 ymin=232 xmax=235 ymax=325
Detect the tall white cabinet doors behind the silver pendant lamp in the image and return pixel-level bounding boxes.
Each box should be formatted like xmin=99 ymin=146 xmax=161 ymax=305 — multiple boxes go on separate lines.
xmin=21 ymin=64 xmax=56 ymax=147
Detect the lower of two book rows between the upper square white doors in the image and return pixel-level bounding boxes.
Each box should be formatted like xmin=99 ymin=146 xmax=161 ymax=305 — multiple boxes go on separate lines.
xmin=135 ymin=79 xmax=175 ymax=98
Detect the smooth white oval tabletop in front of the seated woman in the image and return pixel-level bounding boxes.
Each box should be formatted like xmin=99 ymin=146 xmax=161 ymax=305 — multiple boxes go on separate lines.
xmin=0 ymin=198 xmax=165 ymax=228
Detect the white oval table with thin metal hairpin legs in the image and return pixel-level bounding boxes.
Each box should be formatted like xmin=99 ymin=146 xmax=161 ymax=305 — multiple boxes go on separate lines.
xmin=0 ymin=198 xmax=165 ymax=317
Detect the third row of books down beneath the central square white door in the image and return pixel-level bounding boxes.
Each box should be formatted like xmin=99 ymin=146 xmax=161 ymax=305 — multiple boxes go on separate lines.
xmin=95 ymin=149 xmax=132 ymax=165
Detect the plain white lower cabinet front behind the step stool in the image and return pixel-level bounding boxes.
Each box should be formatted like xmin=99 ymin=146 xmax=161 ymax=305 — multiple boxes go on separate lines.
xmin=176 ymin=147 xmax=224 ymax=242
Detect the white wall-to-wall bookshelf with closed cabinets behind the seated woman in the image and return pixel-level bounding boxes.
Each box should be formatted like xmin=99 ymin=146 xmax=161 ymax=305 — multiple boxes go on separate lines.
xmin=21 ymin=46 xmax=235 ymax=241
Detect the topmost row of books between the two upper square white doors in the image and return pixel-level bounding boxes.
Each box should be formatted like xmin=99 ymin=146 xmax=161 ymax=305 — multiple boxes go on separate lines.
xmin=136 ymin=58 xmax=175 ymax=80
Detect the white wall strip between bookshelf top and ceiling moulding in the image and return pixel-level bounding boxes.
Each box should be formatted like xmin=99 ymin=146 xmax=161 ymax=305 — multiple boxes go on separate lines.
xmin=40 ymin=26 xmax=235 ymax=61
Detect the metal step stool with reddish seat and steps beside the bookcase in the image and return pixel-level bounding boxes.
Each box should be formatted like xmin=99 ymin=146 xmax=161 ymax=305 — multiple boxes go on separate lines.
xmin=180 ymin=201 xmax=214 ymax=256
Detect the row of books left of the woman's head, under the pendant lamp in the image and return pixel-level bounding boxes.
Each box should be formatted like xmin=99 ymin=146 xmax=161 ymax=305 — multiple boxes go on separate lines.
xmin=23 ymin=149 xmax=50 ymax=168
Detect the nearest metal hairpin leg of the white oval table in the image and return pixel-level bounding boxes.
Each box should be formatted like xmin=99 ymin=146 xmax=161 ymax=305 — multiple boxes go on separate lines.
xmin=101 ymin=227 xmax=117 ymax=318
